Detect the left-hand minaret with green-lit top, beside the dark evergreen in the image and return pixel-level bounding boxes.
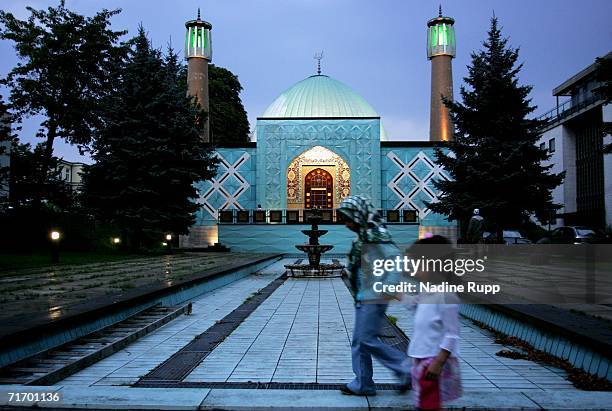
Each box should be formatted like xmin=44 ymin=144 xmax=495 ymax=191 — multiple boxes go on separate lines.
xmin=185 ymin=8 xmax=212 ymax=142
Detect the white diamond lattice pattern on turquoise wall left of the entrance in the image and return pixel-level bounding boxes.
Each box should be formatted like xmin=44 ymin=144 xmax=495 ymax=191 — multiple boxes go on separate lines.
xmin=196 ymin=153 xmax=251 ymax=220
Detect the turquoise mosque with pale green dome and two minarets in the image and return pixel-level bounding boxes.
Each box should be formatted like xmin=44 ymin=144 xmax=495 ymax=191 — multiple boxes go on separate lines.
xmin=180 ymin=9 xmax=456 ymax=253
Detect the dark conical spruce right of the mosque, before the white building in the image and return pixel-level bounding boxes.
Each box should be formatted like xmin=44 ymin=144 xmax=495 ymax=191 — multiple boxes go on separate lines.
xmin=429 ymin=18 xmax=563 ymax=239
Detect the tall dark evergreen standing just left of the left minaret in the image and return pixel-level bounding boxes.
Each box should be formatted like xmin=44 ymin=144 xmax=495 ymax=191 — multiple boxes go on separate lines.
xmin=84 ymin=27 xmax=216 ymax=248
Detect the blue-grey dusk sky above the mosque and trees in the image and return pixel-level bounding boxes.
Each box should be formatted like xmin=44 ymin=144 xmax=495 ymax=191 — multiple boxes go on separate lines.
xmin=0 ymin=0 xmax=612 ymax=162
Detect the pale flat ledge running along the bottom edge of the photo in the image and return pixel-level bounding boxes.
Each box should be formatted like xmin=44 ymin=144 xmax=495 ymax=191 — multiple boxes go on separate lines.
xmin=0 ymin=386 xmax=612 ymax=411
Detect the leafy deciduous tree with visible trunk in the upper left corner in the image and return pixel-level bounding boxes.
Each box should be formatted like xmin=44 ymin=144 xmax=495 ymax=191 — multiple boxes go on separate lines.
xmin=0 ymin=0 xmax=127 ymax=195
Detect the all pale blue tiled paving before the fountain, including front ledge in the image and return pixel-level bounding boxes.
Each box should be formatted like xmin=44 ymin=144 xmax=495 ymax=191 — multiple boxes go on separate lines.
xmin=7 ymin=260 xmax=612 ymax=410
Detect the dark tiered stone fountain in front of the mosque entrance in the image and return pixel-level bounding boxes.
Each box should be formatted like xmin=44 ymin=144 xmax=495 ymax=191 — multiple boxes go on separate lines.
xmin=285 ymin=209 xmax=344 ymax=277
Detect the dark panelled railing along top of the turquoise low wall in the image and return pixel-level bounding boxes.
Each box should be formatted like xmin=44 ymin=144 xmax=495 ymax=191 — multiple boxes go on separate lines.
xmin=218 ymin=209 xmax=419 ymax=224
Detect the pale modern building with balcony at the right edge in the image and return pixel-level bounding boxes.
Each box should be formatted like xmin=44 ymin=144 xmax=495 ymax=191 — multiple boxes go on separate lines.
xmin=538 ymin=53 xmax=612 ymax=228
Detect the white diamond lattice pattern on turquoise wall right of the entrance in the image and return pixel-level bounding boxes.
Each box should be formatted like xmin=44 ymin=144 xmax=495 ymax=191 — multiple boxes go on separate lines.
xmin=387 ymin=151 xmax=450 ymax=219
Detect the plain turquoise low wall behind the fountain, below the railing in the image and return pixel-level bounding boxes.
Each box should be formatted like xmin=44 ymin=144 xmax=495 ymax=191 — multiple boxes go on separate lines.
xmin=218 ymin=224 xmax=419 ymax=254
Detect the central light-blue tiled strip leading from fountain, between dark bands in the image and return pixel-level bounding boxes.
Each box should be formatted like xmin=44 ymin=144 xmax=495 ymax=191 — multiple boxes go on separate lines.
xmin=185 ymin=278 xmax=395 ymax=383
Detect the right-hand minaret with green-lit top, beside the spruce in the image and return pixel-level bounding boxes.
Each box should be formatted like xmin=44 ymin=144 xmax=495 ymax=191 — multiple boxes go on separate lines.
xmin=427 ymin=6 xmax=455 ymax=141
